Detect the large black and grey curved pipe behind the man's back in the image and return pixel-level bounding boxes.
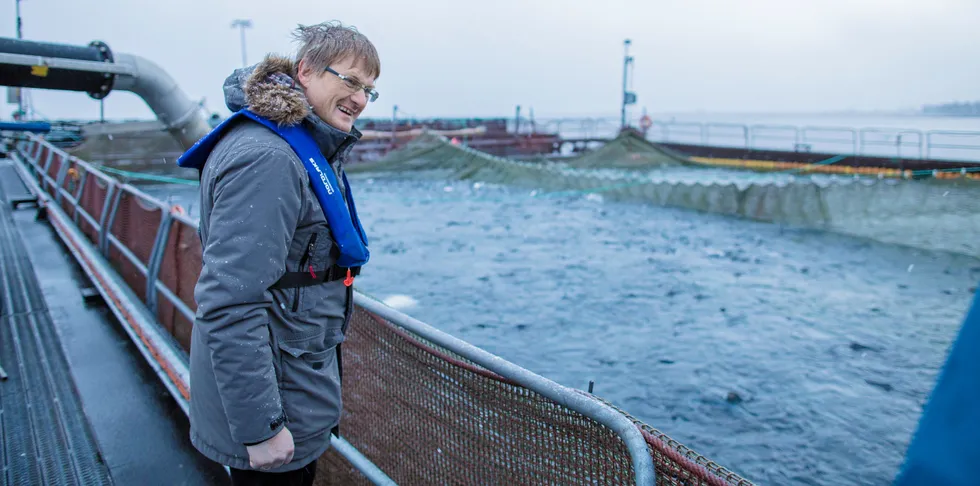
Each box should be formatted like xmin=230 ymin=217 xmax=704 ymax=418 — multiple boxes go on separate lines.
xmin=0 ymin=37 xmax=211 ymax=149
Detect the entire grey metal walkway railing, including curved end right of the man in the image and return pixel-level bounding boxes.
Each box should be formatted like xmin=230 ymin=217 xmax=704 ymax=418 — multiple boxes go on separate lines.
xmin=5 ymin=131 xmax=672 ymax=485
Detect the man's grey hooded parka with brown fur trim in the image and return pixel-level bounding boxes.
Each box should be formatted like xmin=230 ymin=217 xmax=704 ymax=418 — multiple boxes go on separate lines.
xmin=190 ymin=56 xmax=360 ymax=472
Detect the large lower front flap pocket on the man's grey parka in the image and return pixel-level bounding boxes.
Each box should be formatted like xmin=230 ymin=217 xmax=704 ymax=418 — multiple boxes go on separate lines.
xmin=278 ymin=335 xmax=341 ymax=441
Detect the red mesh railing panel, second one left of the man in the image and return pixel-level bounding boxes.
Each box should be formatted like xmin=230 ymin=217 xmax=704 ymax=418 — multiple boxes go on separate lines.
xmin=109 ymin=187 xmax=163 ymax=306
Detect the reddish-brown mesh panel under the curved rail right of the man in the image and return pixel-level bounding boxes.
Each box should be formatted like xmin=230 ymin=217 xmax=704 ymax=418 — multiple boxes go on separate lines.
xmin=318 ymin=308 xmax=634 ymax=485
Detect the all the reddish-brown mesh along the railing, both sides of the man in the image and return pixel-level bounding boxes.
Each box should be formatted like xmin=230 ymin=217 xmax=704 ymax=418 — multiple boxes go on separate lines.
xmin=21 ymin=136 xmax=750 ymax=486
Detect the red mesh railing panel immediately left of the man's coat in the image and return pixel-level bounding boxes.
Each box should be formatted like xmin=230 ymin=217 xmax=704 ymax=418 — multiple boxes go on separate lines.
xmin=157 ymin=218 xmax=201 ymax=352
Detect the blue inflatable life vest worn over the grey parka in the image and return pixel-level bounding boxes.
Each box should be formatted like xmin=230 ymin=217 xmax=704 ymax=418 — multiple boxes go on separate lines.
xmin=177 ymin=109 xmax=370 ymax=268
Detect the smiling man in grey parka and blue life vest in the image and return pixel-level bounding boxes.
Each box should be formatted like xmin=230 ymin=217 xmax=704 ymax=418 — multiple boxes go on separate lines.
xmin=178 ymin=23 xmax=381 ymax=485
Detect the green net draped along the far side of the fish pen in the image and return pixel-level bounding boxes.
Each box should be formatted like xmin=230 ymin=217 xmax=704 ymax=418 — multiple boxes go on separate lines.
xmin=348 ymin=129 xmax=980 ymax=257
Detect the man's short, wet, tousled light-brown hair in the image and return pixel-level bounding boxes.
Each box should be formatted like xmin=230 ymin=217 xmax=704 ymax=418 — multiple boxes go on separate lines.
xmin=293 ymin=21 xmax=381 ymax=78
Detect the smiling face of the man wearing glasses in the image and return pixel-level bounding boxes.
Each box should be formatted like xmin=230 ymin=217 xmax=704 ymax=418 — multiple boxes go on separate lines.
xmin=298 ymin=58 xmax=375 ymax=132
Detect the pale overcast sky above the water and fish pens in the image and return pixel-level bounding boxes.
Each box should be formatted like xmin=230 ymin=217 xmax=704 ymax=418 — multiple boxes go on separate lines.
xmin=0 ymin=0 xmax=980 ymax=119
